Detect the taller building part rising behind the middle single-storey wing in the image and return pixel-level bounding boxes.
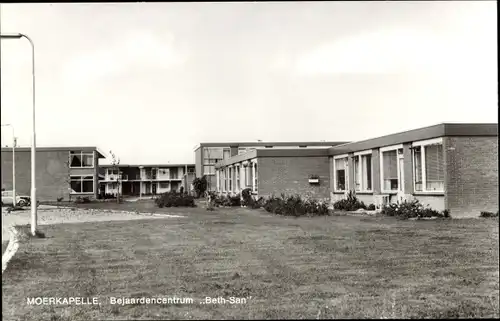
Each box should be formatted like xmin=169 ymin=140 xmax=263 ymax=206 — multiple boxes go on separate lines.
xmin=195 ymin=141 xmax=345 ymax=191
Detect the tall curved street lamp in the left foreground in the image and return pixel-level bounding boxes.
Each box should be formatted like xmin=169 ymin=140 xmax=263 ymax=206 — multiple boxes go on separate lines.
xmin=0 ymin=33 xmax=37 ymax=236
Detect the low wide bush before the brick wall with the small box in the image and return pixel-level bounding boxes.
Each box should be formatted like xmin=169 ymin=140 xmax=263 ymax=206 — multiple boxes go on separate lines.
xmin=264 ymin=194 xmax=329 ymax=217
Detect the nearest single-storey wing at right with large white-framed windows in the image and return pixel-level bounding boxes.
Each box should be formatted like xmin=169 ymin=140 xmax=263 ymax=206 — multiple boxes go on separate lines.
xmin=329 ymin=124 xmax=498 ymax=217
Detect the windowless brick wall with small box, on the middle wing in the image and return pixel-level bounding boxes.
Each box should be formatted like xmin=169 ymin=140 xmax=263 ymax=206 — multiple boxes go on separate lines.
xmin=257 ymin=156 xmax=330 ymax=199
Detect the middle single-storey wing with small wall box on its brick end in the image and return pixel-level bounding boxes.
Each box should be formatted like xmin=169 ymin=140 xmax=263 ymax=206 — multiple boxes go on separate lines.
xmin=216 ymin=148 xmax=336 ymax=200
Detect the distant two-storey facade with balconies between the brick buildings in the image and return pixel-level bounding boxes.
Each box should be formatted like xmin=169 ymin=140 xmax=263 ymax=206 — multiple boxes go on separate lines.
xmin=100 ymin=164 xmax=195 ymax=196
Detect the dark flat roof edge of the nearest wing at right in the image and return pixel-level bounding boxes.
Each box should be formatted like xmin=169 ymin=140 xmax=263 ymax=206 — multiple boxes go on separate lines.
xmin=328 ymin=123 xmax=498 ymax=156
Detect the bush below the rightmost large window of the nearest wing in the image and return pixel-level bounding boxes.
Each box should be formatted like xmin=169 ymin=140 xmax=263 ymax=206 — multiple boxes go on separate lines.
xmin=382 ymin=200 xmax=450 ymax=219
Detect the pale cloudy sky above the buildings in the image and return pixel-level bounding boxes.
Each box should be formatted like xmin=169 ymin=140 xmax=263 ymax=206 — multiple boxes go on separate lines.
xmin=0 ymin=1 xmax=498 ymax=164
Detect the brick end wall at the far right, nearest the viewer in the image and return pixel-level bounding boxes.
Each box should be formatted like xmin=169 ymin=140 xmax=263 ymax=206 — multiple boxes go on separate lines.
xmin=443 ymin=137 xmax=498 ymax=217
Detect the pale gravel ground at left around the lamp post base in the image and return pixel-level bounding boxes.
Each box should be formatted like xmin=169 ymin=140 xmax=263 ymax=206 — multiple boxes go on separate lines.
xmin=2 ymin=205 xmax=182 ymax=242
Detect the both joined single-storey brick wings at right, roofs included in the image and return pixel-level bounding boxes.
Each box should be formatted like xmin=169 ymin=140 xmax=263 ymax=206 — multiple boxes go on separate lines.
xmin=215 ymin=124 xmax=498 ymax=217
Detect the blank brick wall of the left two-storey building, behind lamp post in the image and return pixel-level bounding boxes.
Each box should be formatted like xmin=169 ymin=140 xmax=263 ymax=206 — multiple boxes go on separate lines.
xmin=2 ymin=151 xmax=69 ymax=201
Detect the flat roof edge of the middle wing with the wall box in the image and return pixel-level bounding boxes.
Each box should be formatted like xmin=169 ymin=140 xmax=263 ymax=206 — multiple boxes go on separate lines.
xmin=215 ymin=148 xmax=329 ymax=168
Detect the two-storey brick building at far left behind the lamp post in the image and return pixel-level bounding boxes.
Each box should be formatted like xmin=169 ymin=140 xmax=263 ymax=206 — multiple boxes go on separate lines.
xmin=1 ymin=147 xmax=105 ymax=201
